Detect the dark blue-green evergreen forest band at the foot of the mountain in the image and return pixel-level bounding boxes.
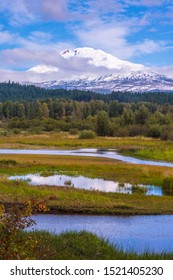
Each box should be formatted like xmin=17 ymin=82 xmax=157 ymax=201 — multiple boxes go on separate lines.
xmin=0 ymin=81 xmax=173 ymax=104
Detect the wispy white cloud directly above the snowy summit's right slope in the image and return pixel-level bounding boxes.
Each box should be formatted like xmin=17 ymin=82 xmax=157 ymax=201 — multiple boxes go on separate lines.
xmin=75 ymin=20 xmax=163 ymax=59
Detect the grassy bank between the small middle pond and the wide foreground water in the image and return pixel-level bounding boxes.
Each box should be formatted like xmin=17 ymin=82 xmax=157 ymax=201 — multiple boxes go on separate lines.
xmin=0 ymin=179 xmax=173 ymax=215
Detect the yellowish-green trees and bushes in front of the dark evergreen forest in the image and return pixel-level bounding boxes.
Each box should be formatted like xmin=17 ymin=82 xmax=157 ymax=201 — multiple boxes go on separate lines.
xmin=0 ymin=98 xmax=173 ymax=140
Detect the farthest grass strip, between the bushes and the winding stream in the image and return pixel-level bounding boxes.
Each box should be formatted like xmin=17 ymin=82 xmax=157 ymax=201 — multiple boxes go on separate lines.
xmin=0 ymin=132 xmax=173 ymax=161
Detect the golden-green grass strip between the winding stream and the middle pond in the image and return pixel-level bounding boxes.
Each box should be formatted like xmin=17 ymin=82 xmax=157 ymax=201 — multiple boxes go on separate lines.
xmin=0 ymin=155 xmax=173 ymax=185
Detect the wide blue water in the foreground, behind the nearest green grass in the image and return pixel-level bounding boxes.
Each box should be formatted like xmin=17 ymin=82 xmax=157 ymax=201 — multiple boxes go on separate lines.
xmin=30 ymin=215 xmax=173 ymax=253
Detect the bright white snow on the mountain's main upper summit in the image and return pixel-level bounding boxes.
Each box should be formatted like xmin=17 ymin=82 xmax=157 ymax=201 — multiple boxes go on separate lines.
xmin=60 ymin=47 xmax=144 ymax=71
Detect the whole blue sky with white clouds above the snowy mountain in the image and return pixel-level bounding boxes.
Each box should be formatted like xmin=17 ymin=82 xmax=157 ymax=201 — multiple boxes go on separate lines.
xmin=0 ymin=0 xmax=173 ymax=80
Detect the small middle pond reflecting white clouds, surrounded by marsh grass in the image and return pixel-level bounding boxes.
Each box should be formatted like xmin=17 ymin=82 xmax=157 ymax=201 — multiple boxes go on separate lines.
xmin=9 ymin=174 xmax=163 ymax=196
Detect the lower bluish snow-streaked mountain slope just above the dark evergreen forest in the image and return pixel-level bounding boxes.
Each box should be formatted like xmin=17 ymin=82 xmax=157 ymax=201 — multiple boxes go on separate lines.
xmin=33 ymin=71 xmax=173 ymax=93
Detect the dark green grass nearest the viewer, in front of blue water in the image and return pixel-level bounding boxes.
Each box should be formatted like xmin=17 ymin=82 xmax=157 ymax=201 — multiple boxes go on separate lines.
xmin=9 ymin=231 xmax=173 ymax=260
